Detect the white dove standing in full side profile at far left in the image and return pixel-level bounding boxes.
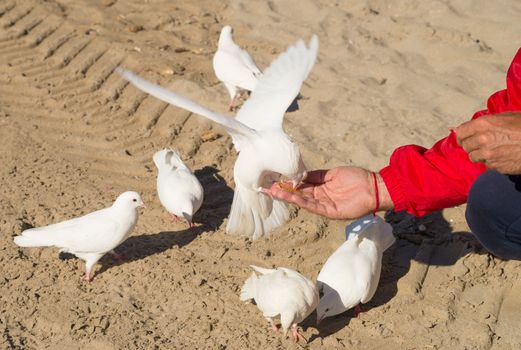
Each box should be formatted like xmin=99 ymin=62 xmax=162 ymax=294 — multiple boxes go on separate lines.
xmin=14 ymin=191 xmax=145 ymax=281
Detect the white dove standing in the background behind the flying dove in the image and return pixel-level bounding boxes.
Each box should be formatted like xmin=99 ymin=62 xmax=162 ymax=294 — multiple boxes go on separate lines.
xmin=213 ymin=26 xmax=262 ymax=111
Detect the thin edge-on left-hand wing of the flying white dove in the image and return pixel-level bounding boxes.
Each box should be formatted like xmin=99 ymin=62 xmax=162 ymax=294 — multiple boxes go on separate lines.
xmin=117 ymin=68 xmax=256 ymax=145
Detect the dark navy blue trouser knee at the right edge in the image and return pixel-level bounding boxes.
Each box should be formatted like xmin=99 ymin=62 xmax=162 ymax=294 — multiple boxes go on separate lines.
xmin=465 ymin=170 xmax=521 ymax=260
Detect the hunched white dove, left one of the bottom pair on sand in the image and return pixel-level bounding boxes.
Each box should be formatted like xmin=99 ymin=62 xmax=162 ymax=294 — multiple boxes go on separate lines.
xmin=240 ymin=265 xmax=319 ymax=342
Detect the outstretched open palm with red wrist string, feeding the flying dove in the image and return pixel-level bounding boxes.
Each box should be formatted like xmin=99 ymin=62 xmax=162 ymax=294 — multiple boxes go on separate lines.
xmin=261 ymin=167 xmax=394 ymax=219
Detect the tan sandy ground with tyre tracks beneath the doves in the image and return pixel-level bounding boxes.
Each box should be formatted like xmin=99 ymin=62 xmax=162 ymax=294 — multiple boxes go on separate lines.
xmin=0 ymin=0 xmax=521 ymax=350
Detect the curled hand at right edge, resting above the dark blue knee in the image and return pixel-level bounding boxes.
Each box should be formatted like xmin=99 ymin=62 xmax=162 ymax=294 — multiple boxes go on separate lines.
xmin=454 ymin=113 xmax=521 ymax=175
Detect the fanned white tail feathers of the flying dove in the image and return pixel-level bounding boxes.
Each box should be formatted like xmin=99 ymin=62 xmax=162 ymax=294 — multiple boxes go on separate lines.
xmin=226 ymin=185 xmax=289 ymax=240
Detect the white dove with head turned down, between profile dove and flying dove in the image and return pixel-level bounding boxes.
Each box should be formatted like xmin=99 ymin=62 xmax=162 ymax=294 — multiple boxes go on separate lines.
xmin=154 ymin=149 xmax=203 ymax=227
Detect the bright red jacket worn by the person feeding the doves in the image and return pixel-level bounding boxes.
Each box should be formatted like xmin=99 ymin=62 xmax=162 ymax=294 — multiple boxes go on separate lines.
xmin=380 ymin=49 xmax=521 ymax=216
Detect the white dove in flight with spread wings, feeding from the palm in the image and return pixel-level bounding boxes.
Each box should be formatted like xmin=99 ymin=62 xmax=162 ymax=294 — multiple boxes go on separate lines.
xmin=118 ymin=35 xmax=318 ymax=239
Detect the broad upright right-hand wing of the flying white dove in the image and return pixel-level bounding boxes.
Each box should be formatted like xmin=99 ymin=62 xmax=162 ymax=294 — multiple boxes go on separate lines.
xmin=235 ymin=35 xmax=318 ymax=130
